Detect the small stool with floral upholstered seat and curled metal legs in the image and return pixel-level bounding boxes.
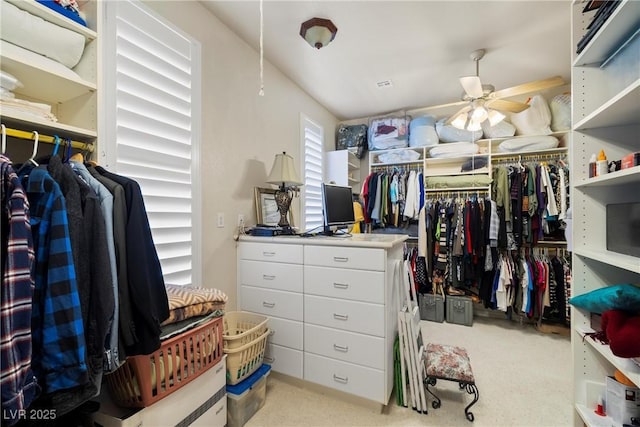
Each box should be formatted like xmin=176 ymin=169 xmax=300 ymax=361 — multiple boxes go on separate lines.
xmin=424 ymin=344 xmax=479 ymax=421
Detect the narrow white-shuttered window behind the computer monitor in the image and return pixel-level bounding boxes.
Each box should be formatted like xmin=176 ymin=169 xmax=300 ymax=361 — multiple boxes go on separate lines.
xmin=300 ymin=115 xmax=324 ymax=231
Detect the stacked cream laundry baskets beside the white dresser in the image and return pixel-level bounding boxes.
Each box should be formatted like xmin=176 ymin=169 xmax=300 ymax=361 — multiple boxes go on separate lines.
xmin=223 ymin=311 xmax=270 ymax=385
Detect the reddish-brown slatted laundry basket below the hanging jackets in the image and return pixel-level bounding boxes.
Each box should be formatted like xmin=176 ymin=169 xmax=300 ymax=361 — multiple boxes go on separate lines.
xmin=106 ymin=317 xmax=223 ymax=408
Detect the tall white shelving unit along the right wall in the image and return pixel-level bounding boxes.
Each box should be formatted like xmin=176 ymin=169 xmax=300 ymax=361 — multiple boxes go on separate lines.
xmin=570 ymin=0 xmax=640 ymax=426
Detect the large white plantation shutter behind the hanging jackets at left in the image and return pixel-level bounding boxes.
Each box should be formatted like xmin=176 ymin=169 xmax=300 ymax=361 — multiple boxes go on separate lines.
xmin=101 ymin=1 xmax=201 ymax=285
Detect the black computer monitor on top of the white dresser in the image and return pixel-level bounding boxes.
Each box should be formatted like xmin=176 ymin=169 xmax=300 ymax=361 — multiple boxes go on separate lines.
xmin=322 ymin=183 xmax=356 ymax=236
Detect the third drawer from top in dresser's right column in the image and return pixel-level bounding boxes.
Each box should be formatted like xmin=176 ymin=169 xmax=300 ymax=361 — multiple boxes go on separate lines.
xmin=304 ymin=295 xmax=384 ymax=337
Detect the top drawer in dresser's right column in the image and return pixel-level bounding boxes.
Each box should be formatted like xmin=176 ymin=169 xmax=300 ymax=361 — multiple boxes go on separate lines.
xmin=304 ymin=246 xmax=385 ymax=271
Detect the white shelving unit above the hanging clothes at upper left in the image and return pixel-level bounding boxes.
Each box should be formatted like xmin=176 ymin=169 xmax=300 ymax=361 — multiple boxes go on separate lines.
xmin=0 ymin=0 xmax=99 ymax=152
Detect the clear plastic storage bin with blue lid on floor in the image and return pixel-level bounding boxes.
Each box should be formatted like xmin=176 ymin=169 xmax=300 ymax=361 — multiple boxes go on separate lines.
xmin=227 ymin=365 xmax=271 ymax=427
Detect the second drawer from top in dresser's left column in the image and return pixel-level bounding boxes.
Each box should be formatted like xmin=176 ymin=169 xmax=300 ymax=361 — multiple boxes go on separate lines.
xmin=238 ymin=260 xmax=303 ymax=292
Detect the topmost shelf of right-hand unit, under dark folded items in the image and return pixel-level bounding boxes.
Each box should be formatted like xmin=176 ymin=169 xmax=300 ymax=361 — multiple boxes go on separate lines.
xmin=572 ymin=0 xmax=640 ymax=67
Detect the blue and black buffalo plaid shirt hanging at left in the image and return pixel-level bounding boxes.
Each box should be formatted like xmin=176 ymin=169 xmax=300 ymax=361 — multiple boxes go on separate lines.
xmin=22 ymin=168 xmax=88 ymax=393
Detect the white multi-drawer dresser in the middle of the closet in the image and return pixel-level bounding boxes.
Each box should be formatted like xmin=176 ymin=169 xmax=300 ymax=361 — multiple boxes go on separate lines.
xmin=238 ymin=234 xmax=407 ymax=405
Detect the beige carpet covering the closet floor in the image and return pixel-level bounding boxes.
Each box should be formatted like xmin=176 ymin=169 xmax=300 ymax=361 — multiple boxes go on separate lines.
xmin=246 ymin=317 xmax=573 ymax=427
